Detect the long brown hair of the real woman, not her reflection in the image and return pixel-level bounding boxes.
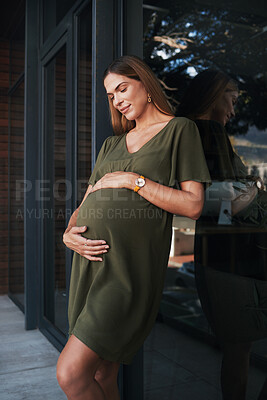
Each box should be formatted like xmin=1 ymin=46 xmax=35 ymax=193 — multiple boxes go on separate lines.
xmin=103 ymin=56 xmax=173 ymax=135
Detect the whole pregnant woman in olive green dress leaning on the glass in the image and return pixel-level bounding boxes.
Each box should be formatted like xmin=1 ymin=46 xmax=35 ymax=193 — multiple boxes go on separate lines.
xmin=58 ymin=56 xmax=209 ymax=400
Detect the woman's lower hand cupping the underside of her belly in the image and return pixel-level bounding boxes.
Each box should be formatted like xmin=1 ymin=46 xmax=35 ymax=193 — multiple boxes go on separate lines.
xmin=63 ymin=226 xmax=109 ymax=261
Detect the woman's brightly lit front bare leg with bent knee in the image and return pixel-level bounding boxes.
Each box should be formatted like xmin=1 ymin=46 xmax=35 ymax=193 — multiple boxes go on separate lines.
xmin=57 ymin=335 xmax=113 ymax=400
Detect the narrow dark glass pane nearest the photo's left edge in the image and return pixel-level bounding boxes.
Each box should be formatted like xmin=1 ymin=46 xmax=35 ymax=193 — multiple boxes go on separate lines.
xmin=9 ymin=81 xmax=24 ymax=305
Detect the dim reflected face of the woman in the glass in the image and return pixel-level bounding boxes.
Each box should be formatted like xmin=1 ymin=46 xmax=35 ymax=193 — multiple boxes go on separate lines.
xmin=210 ymin=87 xmax=241 ymax=125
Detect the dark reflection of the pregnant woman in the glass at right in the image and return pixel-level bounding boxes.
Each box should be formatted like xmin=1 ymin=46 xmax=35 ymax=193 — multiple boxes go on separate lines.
xmin=179 ymin=70 xmax=267 ymax=400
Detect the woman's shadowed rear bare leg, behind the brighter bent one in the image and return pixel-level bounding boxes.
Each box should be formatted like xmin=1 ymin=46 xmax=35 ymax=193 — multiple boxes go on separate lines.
xmin=95 ymin=361 xmax=120 ymax=400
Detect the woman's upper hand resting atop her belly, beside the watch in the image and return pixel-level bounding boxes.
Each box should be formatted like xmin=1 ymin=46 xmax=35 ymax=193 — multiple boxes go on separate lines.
xmin=91 ymin=171 xmax=139 ymax=193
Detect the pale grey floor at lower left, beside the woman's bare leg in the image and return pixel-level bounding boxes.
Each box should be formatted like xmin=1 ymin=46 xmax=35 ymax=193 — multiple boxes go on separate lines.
xmin=0 ymin=296 xmax=66 ymax=400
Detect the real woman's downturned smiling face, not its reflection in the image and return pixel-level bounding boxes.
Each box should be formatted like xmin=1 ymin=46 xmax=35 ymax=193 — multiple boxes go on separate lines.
xmin=104 ymin=73 xmax=151 ymax=121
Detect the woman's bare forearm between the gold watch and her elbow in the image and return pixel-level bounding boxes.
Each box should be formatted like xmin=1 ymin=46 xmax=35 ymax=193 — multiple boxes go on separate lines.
xmin=129 ymin=175 xmax=204 ymax=219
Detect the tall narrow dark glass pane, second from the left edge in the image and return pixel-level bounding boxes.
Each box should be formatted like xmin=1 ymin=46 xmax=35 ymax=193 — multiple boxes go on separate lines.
xmin=43 ymin=46 xmax=67 ymax=333
